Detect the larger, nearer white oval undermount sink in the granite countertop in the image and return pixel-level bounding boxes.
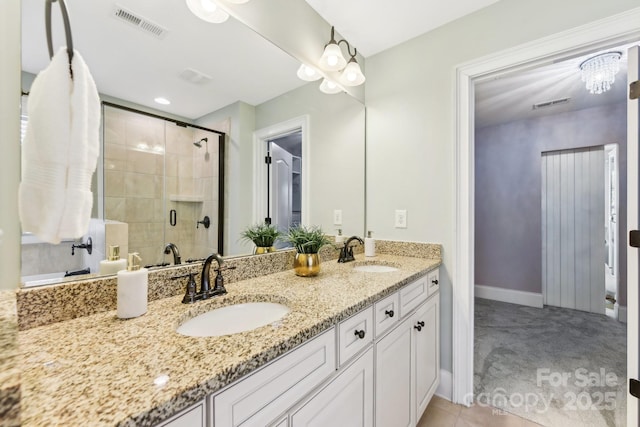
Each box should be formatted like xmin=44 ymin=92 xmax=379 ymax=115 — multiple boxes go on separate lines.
xmin=177 ymin=302 xmax=289 ymax=337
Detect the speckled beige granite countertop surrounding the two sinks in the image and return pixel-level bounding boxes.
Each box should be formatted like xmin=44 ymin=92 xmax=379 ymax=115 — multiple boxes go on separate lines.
xmin=18 ymin=255 xmax=440 ymax=426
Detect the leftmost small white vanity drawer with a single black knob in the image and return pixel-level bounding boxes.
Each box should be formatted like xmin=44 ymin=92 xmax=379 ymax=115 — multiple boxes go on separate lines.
xmin=338 ymin=307 xmax=374 ymax=365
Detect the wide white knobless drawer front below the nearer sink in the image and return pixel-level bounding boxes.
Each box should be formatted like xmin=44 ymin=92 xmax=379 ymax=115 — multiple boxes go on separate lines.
xmin=212 ymin=328 xmax=336 ymax=427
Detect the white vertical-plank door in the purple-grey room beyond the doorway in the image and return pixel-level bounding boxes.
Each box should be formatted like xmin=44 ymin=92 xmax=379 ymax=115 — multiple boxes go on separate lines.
xmin=541 ymin=147 xmax=605 ymax=314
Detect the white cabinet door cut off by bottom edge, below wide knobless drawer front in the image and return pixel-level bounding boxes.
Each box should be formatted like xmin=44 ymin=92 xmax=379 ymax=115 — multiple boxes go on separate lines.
xmin=291 ymin=348 xmax=373 ymax=427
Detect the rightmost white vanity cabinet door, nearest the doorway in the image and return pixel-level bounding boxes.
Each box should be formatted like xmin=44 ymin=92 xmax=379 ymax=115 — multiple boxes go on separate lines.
xmin=411 ymin=294 xmax=440 ymax=421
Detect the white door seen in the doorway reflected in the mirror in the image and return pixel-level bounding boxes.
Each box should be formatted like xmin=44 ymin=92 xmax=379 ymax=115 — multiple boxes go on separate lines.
xmin=269 ymin=142 xmax=293 ymax=246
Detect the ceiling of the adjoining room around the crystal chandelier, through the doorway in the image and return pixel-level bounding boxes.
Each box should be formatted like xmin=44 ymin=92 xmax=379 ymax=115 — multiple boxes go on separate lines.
xmin=475 ymin=45 xmax=629 ymax=127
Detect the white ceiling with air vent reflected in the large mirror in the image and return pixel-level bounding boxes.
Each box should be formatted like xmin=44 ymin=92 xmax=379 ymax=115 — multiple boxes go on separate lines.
xmin=22 ymin=0 xmax=305 ymax=119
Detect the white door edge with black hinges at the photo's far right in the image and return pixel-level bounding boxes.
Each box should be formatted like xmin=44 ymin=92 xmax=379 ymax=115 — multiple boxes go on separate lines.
xmin=627 ymin=46 xmax=640 ymax=426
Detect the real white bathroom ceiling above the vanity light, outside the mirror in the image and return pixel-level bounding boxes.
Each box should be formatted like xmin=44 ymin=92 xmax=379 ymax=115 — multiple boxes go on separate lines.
xmin=306 ymin=0 xmax=498 ymax=57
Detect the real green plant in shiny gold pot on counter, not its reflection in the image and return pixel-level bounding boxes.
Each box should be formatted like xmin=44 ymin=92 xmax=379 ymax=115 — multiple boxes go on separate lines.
xmin=283 ymin=225 xmax=331 ymax=277
